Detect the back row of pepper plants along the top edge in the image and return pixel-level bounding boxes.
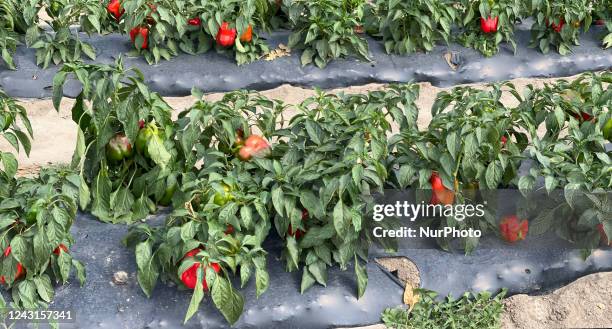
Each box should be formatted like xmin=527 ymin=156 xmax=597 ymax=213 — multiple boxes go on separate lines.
xmin=0 ymin=0 xmax=612 ymax=68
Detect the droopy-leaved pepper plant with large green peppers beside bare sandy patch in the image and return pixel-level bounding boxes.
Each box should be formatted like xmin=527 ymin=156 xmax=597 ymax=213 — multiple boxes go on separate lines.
xmin=53 ymin=58 xmax=176 ymax=223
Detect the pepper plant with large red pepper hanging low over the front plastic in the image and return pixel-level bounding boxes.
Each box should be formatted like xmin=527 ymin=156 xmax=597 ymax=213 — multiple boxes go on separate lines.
xmin=126 ymin=90 xmax=283 ymax=324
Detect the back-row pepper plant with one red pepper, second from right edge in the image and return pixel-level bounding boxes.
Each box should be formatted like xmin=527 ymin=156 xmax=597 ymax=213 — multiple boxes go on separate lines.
xmin=459 ymin=0 xmax=523 ymax=57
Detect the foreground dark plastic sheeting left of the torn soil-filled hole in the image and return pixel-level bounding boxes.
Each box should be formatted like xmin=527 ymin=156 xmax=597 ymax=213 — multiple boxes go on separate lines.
xmin=2 ymin=214 xmax=403 ymax=329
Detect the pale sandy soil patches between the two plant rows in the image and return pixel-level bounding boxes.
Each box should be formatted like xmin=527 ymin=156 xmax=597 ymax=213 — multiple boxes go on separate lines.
xmin=0 ymin=75 xmax=572 ymax=172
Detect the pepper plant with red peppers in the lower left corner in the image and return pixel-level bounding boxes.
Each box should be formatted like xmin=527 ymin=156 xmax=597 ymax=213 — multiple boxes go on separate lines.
xmin=0 ymin=169 xmax=85 ymax=318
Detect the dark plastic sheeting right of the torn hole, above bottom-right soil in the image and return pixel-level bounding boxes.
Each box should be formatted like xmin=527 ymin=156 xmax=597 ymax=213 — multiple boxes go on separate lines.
xmin=371 ymin=232 xmax=612 ymax=297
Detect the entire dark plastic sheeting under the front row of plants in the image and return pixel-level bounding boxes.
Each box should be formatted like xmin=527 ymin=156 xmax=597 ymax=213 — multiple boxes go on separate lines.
xmin=5 ymin=210 xmax=612 ymax=329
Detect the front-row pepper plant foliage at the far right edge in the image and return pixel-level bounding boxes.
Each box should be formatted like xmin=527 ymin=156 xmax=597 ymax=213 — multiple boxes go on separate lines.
xmin=519 ymin=72 xmax=612 ymax=249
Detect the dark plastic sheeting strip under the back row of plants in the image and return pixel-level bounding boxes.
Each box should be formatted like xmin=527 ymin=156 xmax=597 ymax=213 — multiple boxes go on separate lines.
xmin=0 ymin=22 xmax=612 ymax=98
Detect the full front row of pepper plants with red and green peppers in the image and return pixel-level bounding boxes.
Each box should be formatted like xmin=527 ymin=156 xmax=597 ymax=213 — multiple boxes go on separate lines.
xmin=0 ymin=59 xmax=588 ymax=323
